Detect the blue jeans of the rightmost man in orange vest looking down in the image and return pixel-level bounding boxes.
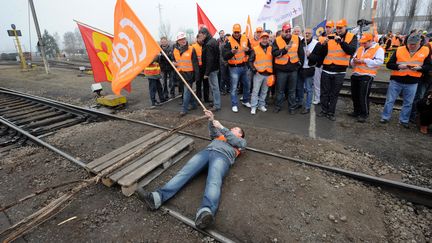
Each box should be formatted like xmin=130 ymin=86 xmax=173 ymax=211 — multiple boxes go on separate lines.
xmin=381 ymin=80 xmax=417 ymax=123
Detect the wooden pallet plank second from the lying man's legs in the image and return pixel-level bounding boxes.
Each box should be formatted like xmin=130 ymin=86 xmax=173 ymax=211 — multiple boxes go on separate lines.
xmin=108 ymin=135 xmax=184 ymax=181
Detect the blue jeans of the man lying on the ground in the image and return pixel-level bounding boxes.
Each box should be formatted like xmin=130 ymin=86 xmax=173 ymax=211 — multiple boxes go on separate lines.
xmin=153 ymin=149 xmax=231 ymax=215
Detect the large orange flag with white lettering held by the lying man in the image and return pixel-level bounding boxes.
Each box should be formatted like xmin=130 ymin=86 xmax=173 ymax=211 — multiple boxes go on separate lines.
xmin=109 ymin=0 xmax=161 ymax=94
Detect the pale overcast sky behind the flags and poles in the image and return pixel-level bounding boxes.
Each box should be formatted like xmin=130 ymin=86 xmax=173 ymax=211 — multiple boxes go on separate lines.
xmin=0 ymin=0 xmax=282 ymax=52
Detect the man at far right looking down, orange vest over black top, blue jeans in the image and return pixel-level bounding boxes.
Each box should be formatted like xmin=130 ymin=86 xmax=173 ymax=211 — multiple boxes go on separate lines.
xmin=380 ymin=34 xmax=431 ymax=128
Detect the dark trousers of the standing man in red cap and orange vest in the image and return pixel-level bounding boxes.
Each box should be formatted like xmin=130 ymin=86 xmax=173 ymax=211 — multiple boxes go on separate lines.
xmin=276 ymin=71 xmax=298 ymax=110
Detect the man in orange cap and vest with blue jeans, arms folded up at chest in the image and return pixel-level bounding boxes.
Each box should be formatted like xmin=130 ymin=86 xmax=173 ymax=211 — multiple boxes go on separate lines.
xmin=222 ymin=24 xmax=251 ymax=112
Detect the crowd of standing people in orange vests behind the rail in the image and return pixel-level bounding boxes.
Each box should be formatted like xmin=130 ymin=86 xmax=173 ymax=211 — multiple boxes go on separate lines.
xmin=144 ymin=19 xmax=432 ymax=133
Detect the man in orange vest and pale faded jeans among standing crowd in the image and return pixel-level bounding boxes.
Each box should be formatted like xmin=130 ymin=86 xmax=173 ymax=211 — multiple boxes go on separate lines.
xmin=249 ymin=32 xmax=274 ymax=115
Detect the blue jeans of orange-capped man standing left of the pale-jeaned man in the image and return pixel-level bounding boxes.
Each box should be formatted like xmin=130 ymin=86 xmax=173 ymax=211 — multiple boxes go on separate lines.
xmin=229 ymin=66 xmax=249 ymax=106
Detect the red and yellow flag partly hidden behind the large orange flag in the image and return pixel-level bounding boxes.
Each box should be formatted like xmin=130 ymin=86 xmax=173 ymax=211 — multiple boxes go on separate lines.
xmin=77 ymin=23 xmax=131 ymax=92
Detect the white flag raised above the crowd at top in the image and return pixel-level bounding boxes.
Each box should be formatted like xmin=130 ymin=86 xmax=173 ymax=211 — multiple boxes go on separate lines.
xmin=258 ymin=0 xmax=303 ymax=24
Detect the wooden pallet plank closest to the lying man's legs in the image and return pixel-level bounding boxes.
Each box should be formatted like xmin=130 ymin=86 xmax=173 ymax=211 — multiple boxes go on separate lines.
xmin=118 ymin=137 xmax=193 ymax=186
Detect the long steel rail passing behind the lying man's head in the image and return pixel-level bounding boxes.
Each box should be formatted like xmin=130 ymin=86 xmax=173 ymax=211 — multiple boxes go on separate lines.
xmin=0 ymin=88 xmax=432 ymax=207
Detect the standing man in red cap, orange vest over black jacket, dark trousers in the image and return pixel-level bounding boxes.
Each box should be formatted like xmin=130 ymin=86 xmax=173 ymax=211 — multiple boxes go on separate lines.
xmin=272 ymin=24 xmax=304 ymax=115
